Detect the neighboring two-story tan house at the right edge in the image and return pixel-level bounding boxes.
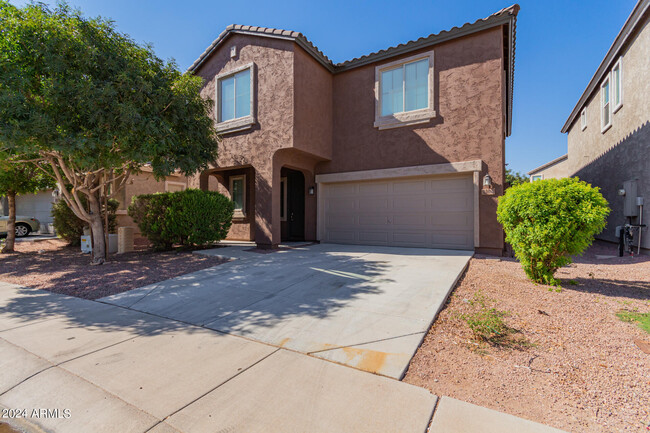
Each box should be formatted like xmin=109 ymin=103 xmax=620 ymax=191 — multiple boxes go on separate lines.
xmin=562 ymin=0 xmax=650 ymax=249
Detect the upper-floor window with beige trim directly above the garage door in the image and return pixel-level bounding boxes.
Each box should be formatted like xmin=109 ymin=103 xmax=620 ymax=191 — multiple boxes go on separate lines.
xmin=375 ymin=52 xmax=435 ymax=129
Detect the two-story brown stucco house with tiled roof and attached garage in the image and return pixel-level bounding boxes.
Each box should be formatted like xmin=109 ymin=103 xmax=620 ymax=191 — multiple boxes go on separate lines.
xmin=189 ymin=5 xmax=519 ymax=254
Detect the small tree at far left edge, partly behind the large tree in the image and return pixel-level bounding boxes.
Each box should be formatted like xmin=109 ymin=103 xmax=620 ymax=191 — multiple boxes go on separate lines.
xmin=0 ymin=151 xmax=54 ymax=253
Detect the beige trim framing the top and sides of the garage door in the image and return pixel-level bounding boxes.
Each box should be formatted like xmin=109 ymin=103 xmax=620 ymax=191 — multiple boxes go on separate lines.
xmin=316 ymin=160 xmax=483 ymax=248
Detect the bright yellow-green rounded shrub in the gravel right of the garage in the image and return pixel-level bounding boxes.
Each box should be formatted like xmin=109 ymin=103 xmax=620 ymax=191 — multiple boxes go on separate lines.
xmin=497 ymin=178 xmax=609 ymax=285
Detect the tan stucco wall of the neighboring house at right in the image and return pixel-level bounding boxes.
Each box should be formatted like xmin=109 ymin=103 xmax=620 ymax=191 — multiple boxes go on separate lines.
xmin=567 ymin=14 xmax=650 ymax=252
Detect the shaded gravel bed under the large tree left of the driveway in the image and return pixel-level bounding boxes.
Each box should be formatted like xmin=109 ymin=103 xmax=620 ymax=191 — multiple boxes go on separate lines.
xmin=0 ymin=239 xmax=224 ymax=299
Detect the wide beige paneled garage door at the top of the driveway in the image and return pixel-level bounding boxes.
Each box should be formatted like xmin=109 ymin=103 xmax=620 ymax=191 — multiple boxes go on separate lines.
xmin=320 ymin=175 xmax=474 ymax=250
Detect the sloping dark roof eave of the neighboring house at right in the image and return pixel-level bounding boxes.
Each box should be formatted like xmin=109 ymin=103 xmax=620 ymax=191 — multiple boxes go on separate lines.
xmin=561 ymin=0 xmax=650 ymax=133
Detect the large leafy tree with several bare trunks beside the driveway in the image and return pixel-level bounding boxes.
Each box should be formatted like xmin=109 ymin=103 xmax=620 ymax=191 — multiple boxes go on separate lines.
xmin=0 ymin=0 xmax=218 ymax=263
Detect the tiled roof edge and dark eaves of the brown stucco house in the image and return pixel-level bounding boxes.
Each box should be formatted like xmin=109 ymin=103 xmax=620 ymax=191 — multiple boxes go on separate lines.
xmin=187 ymin=4 xmax=519 ymax=135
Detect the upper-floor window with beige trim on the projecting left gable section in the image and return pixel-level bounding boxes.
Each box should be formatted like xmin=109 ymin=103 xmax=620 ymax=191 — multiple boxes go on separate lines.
xmin=216 ymin=63 xmax=255 ymax=132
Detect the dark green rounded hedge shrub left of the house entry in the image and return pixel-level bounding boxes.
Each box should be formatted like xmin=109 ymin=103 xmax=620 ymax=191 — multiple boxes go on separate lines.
xmin=129 ymin=189 xmax=234 ymax=250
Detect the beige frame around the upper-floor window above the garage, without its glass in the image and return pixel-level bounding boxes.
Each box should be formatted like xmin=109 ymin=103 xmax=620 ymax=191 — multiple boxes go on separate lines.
xmin=374 ymin=51 xmax=436 ymax=130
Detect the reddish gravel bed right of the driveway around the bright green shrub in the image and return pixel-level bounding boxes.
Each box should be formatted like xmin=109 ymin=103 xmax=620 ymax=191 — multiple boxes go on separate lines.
xmin=404 ymin=243 xmax=650 ymax=432
